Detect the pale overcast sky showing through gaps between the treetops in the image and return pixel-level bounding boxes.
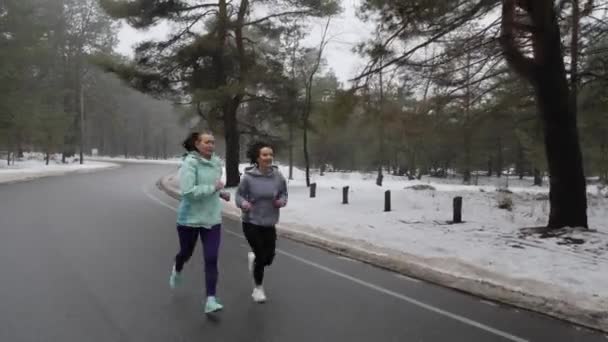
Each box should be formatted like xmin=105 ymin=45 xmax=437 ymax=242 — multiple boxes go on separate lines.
xmin=117 ymin=0 xmax=373 ymax=86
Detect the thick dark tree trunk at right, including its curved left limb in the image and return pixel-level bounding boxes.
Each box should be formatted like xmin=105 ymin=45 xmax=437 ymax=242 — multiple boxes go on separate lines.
xmin=501 ymin=0 xmax=588 ymax=228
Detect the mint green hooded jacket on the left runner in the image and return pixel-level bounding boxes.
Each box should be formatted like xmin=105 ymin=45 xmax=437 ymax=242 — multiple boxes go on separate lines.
xmin=177 ymin=152 xmax=222 ymax=229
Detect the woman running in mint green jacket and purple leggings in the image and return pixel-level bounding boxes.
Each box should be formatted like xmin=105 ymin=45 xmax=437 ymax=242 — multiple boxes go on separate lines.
xmin=169 ymin=133 xmax=230 ymax=313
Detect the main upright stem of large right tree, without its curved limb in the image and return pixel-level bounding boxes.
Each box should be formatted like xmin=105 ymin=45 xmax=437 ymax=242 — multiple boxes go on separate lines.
xmin=535 ymin=5 xmax=588 ymax=228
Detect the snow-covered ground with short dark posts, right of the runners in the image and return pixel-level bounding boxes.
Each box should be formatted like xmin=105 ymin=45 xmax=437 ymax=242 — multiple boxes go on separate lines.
xmin=216 ymin=165 xmax=608 ymax=304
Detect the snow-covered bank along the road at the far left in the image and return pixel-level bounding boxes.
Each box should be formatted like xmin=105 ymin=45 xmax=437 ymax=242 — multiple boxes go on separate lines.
xmin=0 ymin=153 xmax=118 ymax=184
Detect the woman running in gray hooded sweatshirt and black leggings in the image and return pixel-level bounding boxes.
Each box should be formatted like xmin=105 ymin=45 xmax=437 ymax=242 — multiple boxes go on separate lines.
xmin=236 ymin=142 xmax=287 ymax=303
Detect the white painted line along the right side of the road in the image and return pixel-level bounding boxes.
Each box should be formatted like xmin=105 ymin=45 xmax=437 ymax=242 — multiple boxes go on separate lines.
xmin=142 ymin=187 xmax=528 ymax=342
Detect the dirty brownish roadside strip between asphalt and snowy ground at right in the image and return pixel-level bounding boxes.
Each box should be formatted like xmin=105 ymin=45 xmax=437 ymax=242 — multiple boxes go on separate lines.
xmin=157 ymin=174 xmax=608 ymax=332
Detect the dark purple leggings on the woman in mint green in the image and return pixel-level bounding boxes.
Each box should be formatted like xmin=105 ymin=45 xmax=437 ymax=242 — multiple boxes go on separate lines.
xmin=175 ymin=224 xmax=222 ymax=296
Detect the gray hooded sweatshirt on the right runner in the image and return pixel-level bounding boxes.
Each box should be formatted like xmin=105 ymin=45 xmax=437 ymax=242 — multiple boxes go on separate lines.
xmin=235 ymin=166 xmax=287 ymax=227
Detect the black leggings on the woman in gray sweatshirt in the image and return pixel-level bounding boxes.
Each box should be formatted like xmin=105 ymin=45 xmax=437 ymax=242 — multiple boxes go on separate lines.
xmin=243 ymin=222 xmax=277 ymax=286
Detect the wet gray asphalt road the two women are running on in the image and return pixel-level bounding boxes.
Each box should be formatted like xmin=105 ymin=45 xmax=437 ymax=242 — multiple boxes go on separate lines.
xmin=0 ymin=165 xmax=608 ymax=342
